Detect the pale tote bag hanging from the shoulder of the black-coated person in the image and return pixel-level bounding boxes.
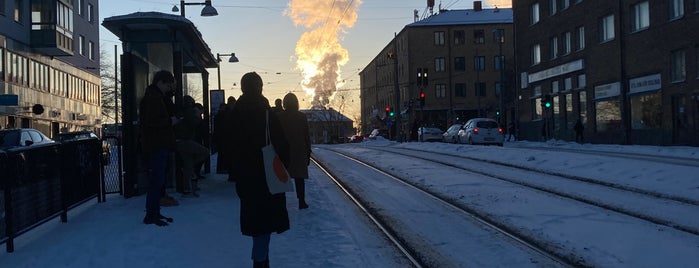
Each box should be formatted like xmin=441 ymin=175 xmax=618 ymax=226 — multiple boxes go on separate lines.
xmin=262 ymin=111 xmax=294 ymax=194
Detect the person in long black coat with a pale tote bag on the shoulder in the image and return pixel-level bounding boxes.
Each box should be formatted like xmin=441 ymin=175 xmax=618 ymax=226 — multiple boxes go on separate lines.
xmin=227 ymin=72 xmax=289 ymax=267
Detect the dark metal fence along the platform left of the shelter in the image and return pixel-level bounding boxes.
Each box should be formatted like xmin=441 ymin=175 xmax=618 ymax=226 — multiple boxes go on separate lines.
xmin=0 ymin=138 xmax=122 ymax=252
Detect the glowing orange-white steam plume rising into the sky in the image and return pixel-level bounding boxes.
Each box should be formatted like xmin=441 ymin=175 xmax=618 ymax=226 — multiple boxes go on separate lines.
xmin=285 ymin=0 xmax=362 ymax=107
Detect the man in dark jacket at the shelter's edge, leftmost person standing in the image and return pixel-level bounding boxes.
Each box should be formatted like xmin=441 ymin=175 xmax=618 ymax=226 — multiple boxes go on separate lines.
xmin=139 ymin=71 xmax=179 ymax=226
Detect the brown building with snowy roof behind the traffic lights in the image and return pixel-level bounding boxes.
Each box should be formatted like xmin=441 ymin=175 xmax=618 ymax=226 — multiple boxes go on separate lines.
xmin=360 ymin=1 xmax=515 ymax=140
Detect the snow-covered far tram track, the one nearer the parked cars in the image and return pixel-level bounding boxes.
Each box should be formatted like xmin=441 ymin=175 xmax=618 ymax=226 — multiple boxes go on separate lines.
xmin=348 ymin=148 xmax=699 ymax=236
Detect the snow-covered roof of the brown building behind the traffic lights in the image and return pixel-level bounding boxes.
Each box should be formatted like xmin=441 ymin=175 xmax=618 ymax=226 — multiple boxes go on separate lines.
xmin=406 ymin=8 xmax=513 ymax=27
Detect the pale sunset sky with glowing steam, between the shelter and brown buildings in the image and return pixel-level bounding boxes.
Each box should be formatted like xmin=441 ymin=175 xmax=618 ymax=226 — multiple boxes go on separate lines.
xmin=99 ymin=0 xmax=511 ymax=119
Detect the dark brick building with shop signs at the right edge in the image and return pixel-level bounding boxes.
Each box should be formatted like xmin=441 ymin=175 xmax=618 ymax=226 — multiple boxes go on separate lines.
xmin=513 ymin=0 xmax=699 ymax=146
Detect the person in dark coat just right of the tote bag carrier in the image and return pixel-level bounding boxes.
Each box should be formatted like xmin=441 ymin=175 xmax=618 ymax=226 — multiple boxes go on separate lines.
xmin=279 ymin=93 xmax=311 ymax=209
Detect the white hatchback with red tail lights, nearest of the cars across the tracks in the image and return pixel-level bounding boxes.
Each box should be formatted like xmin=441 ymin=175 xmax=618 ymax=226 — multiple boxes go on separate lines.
xmin=457 ymin=118 xmax=505 ymax=146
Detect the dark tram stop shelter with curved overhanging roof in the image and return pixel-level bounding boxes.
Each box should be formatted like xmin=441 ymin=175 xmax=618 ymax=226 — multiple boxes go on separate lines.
xmin=102 ymin=12 xmax=218 ymax=197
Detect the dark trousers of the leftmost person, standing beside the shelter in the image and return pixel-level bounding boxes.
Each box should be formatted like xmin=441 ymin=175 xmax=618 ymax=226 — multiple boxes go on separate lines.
xmin=146 ymin=149 xmax=170 ymax=216
